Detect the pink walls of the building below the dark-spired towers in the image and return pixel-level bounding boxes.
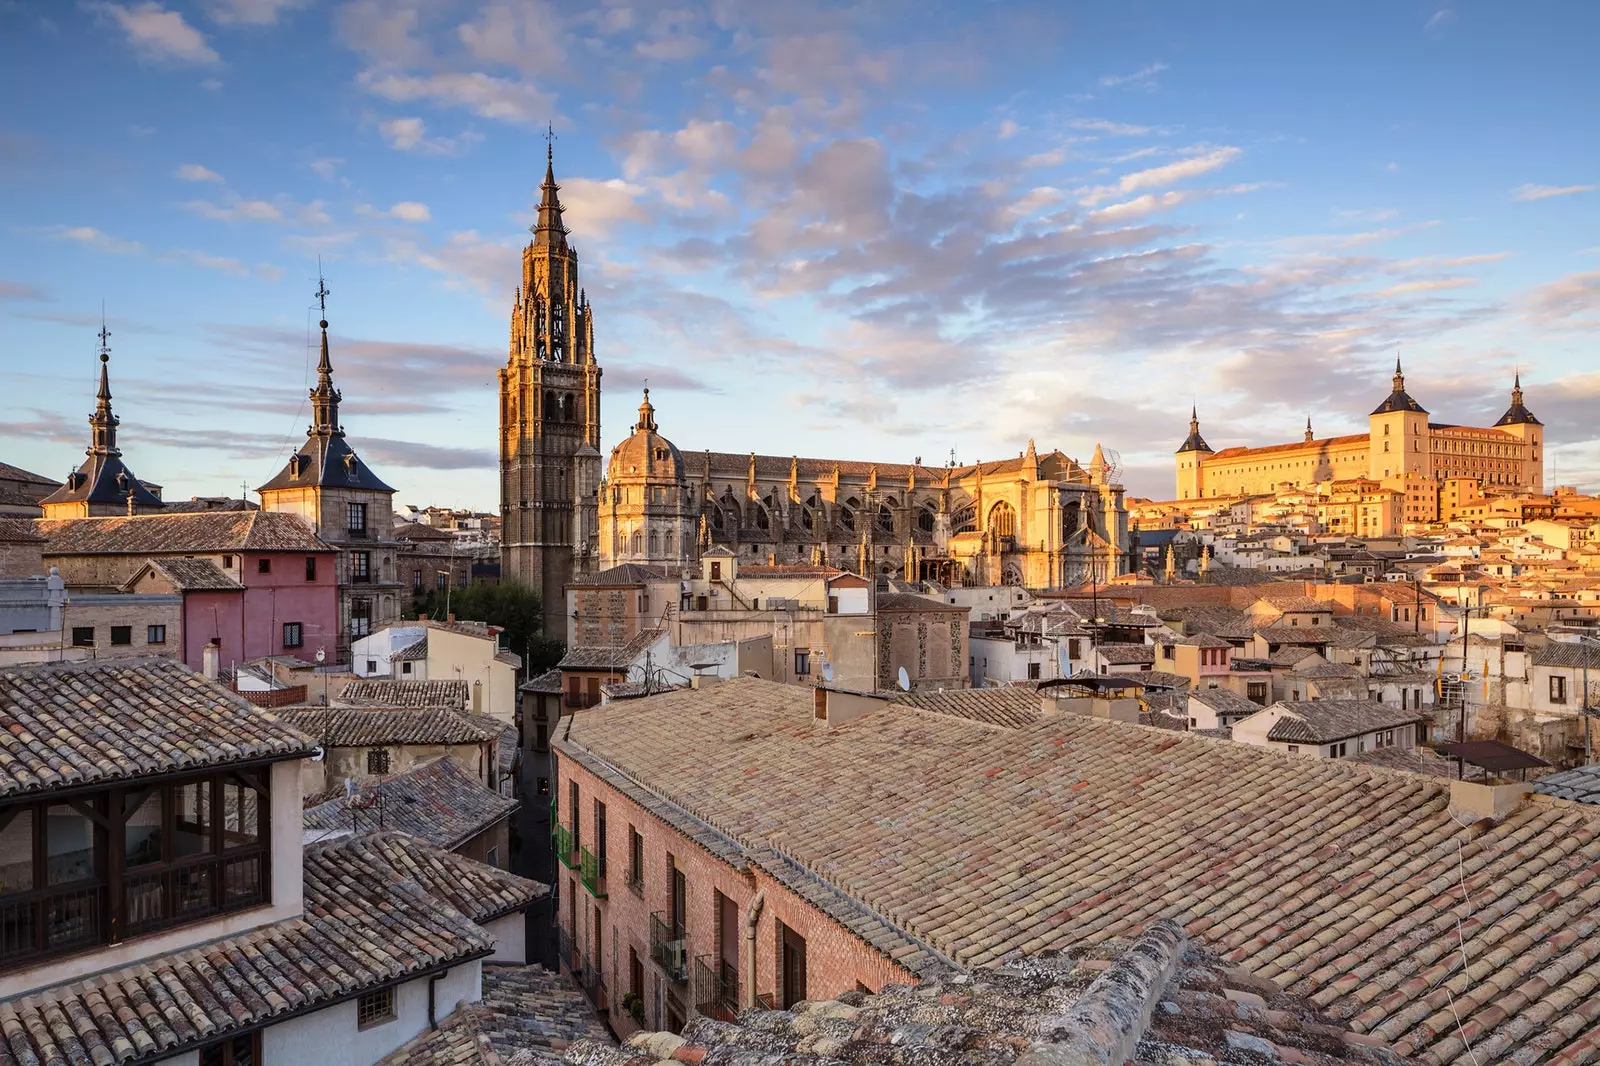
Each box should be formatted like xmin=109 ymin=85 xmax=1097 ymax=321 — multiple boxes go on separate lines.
xmin=184 ymin=552 xmax=339 ymax=669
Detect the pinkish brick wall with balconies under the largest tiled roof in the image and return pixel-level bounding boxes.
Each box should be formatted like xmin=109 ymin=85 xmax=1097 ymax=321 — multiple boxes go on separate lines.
xmin=555 ymin=754 xmax=915 ymax=1032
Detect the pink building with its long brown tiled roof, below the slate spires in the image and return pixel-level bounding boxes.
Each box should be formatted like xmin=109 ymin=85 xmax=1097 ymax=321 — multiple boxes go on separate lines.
xmin=35 ymin=511 xmax=339 ymax=669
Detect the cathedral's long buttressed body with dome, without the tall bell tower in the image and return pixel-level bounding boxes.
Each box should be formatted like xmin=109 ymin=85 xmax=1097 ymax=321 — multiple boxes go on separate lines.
xmin=600 ymin=392 xmax=1131 ymax=587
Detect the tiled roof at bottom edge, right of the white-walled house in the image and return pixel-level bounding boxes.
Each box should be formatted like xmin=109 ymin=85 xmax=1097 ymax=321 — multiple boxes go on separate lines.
xmin=378 ymin=965 xmax=611 ymax=1066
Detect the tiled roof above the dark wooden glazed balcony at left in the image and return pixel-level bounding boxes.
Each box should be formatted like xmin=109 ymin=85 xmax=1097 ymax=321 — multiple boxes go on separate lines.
xmin=0 ymin=659 xmax=312 ymax=797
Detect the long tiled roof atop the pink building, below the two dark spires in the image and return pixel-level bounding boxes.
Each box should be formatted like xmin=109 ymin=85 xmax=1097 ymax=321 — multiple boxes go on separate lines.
xmin=34 ymin=511 xmax=333 ymax=555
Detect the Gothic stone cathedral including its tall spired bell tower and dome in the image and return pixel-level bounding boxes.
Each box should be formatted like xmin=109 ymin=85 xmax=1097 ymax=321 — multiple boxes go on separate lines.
xmin=499 ymin=154 xmax=1131 ymax=605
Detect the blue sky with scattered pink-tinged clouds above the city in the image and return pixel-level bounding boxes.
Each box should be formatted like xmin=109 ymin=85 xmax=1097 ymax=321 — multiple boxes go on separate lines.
xmin=0 ymin=0 xmax=1600 ymax=511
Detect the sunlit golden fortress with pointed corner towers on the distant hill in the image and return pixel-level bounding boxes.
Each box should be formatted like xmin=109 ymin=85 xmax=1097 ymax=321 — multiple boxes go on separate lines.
xmin=1174 ymin=360 xmax=1544 ymax=522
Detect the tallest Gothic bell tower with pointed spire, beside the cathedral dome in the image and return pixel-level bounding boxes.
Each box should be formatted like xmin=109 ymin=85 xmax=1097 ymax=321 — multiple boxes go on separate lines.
xmin=499 ymin=143 xmax=600 ymax=639
